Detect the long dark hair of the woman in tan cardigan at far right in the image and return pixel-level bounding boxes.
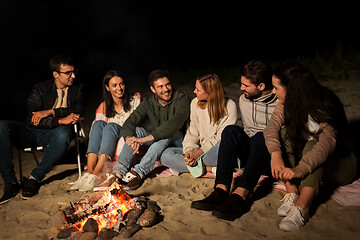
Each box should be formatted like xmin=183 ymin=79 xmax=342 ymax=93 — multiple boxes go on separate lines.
xmin=274 ymin=62 xmax=347 ymax=155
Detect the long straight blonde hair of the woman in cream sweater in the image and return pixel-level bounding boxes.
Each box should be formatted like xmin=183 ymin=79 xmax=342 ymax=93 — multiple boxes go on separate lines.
xmin=196 ymin=73 xmax=227 ymax=124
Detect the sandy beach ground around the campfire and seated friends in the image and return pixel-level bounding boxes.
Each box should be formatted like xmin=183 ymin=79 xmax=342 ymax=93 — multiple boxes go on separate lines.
xmin=0 ymin=80 xmax=360 ymax=240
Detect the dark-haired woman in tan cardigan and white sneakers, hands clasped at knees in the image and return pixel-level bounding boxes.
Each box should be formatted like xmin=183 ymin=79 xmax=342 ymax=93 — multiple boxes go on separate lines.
xmin=264 ymin=63 xmax=357 ymax=231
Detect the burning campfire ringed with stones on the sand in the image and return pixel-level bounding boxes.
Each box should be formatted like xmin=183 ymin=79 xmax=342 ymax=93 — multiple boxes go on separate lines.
xmin=48 ymin=182 xmax=161 ymax=239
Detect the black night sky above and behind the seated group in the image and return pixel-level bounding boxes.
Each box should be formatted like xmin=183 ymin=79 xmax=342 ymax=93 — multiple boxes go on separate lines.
xmin=0 ymin=0 xmax=360 ymax=120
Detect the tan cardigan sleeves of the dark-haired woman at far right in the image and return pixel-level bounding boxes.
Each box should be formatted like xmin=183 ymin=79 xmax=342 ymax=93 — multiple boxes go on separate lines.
xmin=264 ymin=103 xmax=337 ymax=176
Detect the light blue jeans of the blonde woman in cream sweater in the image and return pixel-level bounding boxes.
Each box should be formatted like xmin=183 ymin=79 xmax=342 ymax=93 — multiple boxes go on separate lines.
xmin=160 ymin=141 xmax=220 ymax=172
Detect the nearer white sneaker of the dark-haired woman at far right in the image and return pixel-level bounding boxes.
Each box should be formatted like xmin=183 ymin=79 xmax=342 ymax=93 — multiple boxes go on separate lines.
xmin=279 ymin=205 xmax=309 ymax=231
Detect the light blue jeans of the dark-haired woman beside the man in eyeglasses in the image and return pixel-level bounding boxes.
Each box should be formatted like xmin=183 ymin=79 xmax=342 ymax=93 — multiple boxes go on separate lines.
xmin=87 ymin=120 xmax=121 ymax=157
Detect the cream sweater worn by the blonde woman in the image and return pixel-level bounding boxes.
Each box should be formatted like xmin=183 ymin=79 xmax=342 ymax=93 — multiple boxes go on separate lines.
xmin=183 ymin=98 xmax=237 ymax=153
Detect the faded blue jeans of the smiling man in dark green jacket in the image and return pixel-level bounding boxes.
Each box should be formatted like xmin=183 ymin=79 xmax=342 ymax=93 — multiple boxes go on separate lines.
xmin=113 ymin=127 xmax=183 ymax=178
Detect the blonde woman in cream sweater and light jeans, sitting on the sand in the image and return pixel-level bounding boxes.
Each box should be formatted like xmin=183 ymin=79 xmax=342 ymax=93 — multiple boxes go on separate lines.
xmin=160 ymin=74 xmax=237 ymax=173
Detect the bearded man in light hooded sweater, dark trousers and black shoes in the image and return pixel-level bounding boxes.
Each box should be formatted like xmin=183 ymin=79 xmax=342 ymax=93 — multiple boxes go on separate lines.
xmin=191 ymin=60 xmax=278 ymax=221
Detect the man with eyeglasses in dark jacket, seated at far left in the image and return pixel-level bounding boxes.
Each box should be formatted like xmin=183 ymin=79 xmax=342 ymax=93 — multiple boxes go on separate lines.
xmin=0 ymin=54 xmax=84 ymax=204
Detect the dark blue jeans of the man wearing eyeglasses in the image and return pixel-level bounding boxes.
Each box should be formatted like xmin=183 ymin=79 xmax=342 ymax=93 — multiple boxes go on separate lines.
xmin=0 ymin=120 xmax=72 ymax=183
